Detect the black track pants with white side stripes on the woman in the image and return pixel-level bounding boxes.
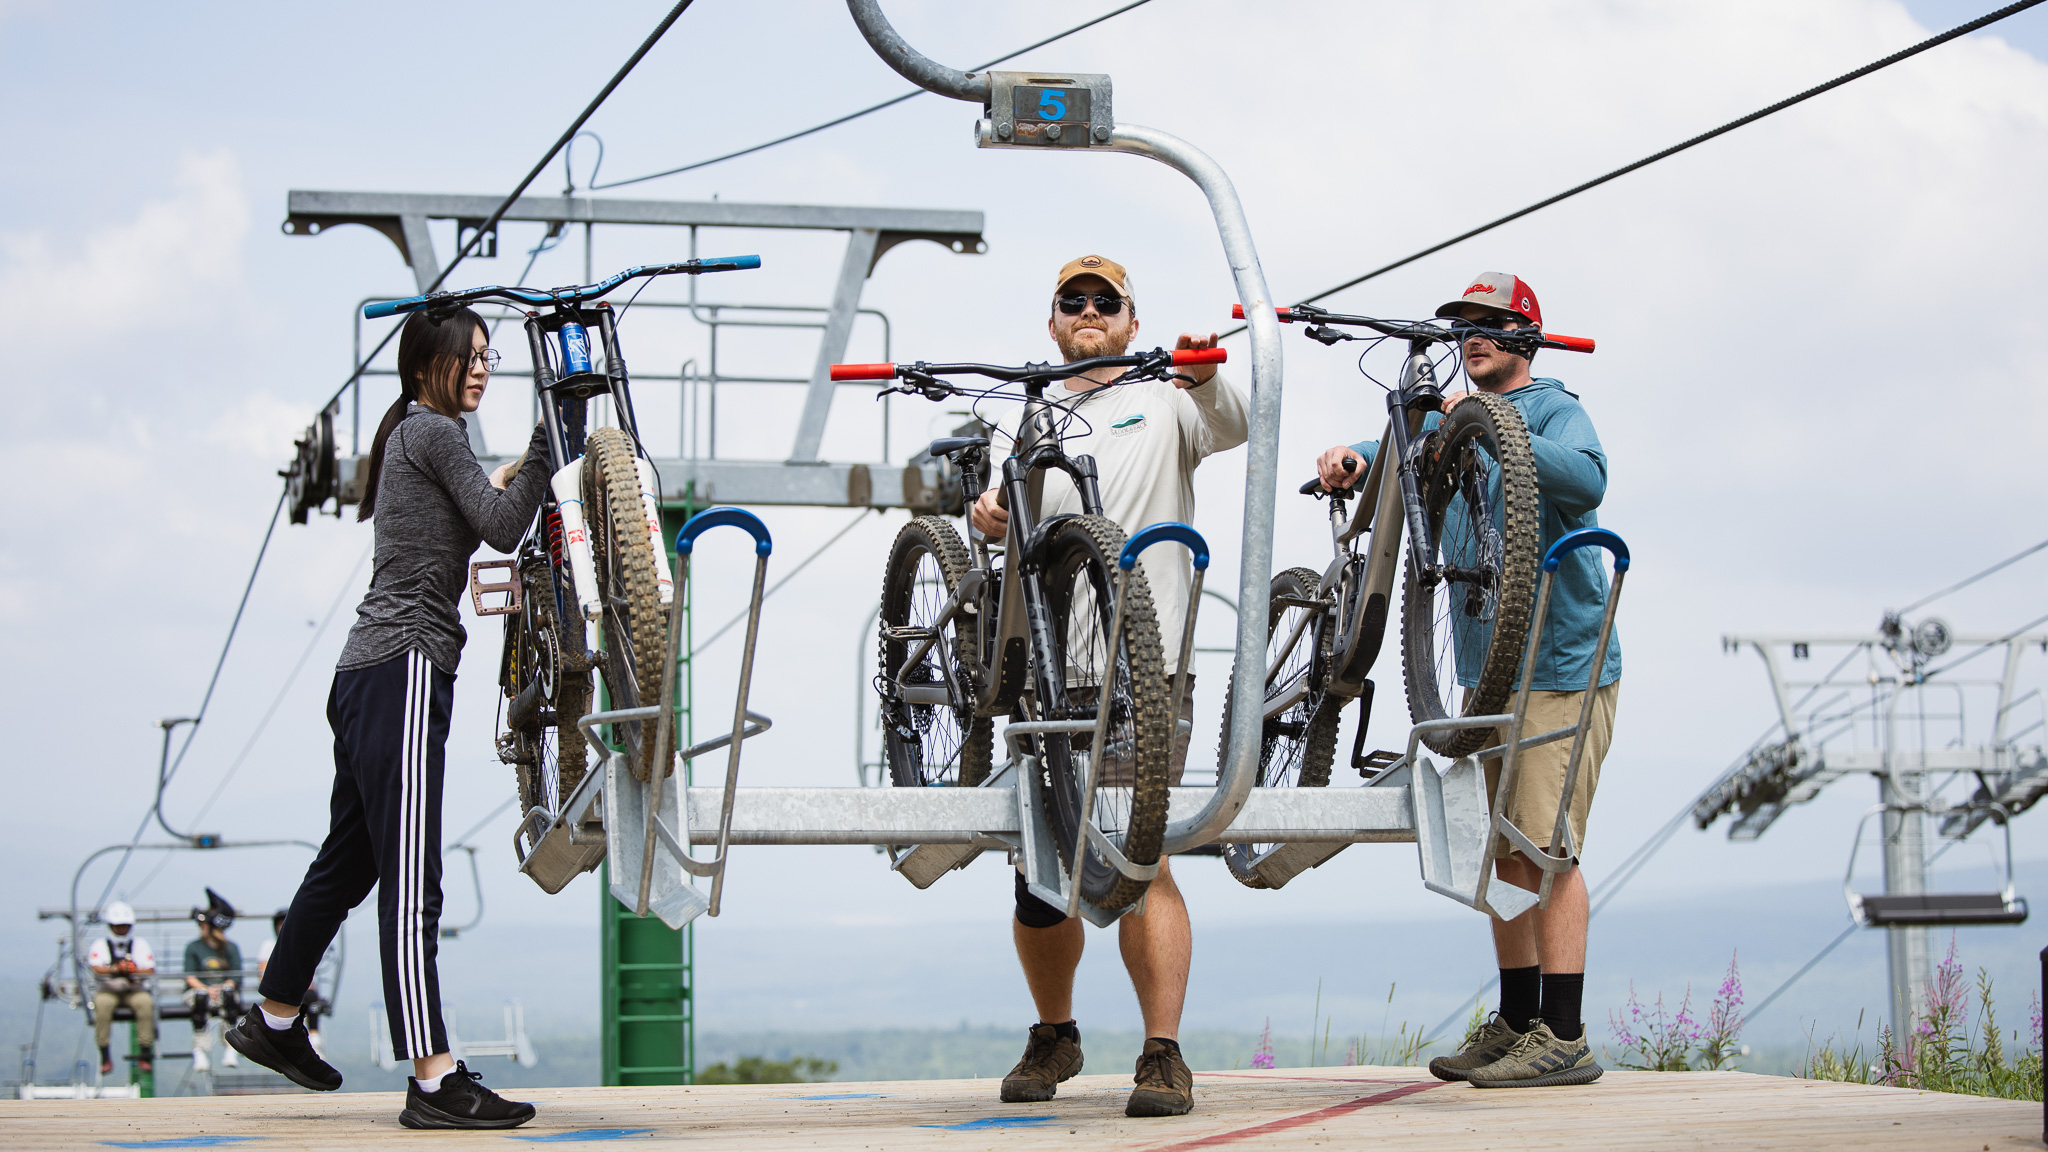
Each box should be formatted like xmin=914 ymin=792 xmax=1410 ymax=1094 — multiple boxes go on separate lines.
xmin=262 ymin=650 xmax=455 ymax=1060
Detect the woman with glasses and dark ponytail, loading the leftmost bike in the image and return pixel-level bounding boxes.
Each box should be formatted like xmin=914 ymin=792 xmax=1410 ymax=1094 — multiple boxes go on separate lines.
xmin=227 ymin=307 xmax=551 ymax=1127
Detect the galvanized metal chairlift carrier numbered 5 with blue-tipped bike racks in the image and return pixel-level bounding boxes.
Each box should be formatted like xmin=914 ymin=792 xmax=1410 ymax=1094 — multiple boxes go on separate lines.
xmin=537 ymin=0 xmax=1626 ymax=927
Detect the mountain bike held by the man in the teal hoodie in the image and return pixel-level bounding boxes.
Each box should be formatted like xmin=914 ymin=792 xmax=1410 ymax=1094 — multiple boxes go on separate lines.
xmin=1225 ymin=303 xmax=1593 ymax=888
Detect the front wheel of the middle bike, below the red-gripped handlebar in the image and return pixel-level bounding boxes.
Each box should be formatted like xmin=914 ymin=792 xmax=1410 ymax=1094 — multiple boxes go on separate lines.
xmin=1038 ymin=517 xmax=1174 ymax=910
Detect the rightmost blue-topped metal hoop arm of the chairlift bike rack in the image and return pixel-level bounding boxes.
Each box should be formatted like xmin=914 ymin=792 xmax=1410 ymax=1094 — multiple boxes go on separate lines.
xmin=1475 ymin=529 xmax=1628 ymax=908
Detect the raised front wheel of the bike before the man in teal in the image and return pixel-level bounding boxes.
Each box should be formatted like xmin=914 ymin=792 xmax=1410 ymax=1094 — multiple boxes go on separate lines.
xmin=1401 ymin=392 xmax=1538 ymax=756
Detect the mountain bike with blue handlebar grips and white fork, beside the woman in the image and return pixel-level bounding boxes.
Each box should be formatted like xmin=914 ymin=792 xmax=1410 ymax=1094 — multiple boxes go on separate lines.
xmin=362 ymin=256 xmax=760 ymax=892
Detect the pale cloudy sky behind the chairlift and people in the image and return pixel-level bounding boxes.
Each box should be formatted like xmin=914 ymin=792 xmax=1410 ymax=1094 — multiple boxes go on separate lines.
xmin=0 ymin=0 xmax=2048 ymax=1057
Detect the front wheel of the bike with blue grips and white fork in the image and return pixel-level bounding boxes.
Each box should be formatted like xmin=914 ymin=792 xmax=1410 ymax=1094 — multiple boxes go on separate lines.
xmin=584 ymin=428 xmax=674 ymax=781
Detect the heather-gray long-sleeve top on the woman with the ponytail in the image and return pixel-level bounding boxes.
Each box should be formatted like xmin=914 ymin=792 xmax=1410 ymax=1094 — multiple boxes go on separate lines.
xmin=336 ymin=404 xmax=553 ymax=674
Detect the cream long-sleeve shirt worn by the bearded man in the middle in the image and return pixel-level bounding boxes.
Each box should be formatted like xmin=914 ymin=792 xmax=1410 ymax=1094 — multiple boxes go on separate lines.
xmin=997 ymin=371 xmax=1249 ymax=672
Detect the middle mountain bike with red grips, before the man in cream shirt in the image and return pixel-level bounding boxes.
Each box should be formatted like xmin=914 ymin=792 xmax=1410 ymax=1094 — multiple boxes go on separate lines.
xmin=831 ymin=340 xmax=1225 ymax=912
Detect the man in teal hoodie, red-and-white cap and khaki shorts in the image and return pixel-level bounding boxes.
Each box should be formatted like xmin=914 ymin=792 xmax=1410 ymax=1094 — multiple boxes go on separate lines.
xmin=1317 ymin=273 xmax=1622 ymax=1088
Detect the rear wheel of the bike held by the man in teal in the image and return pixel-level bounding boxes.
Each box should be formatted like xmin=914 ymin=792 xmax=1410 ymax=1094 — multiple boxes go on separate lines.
xmin=1219 ymin=568 xmax=1343 ymax=888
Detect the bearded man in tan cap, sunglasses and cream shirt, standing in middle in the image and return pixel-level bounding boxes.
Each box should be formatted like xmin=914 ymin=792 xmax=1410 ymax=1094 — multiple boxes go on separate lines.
xmin=973 ymin=256 xmax=1247 ymax=1115
